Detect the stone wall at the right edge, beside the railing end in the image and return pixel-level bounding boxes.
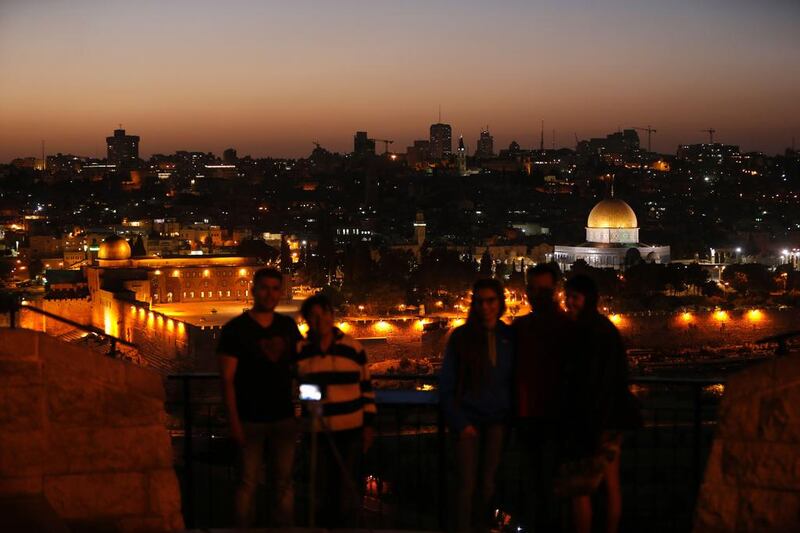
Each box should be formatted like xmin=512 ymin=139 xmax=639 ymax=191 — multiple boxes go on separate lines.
xmin=694 ymin=353 xmax=800 ymax=533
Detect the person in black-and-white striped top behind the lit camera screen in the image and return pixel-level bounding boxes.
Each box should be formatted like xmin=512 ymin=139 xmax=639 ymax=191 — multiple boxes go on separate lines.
xmin=296 ymin=295 xmax=376 ymax=528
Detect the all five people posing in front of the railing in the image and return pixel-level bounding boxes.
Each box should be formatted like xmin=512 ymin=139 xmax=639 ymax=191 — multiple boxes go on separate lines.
xmin=217 ymin=266 xmax=640 ymax=533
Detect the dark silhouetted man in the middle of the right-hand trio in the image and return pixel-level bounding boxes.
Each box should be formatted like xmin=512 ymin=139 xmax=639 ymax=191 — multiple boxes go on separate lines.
xmin=513 ymin=265 xmax=573 ymax=531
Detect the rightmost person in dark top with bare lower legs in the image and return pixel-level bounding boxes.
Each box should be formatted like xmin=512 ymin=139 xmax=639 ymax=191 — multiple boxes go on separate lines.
xmin=556 ymin=275 xmax=641 ymax=533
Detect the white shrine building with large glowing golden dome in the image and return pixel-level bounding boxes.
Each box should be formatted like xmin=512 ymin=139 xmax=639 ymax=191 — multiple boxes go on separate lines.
xmin=553 ymin=198 xmax=670 ymax=270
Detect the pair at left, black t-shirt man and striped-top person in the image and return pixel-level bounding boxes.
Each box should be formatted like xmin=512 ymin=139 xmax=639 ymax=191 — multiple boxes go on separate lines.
xmin=217 ymin=268 xmax=376 ymax=528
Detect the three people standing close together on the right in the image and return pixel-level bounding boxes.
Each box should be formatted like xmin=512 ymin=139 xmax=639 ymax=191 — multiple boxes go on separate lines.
xmin=439 ymin=265 xmax=641 ymax=533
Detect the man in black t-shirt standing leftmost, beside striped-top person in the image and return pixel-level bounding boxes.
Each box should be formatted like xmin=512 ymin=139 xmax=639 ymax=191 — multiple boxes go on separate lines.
xmin=217 ymin=268 xmax=302 ymax=527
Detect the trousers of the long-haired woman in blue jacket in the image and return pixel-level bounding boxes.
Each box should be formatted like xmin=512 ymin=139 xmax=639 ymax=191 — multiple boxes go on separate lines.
xmin=455 ymin=424 xmax=506 ymax=533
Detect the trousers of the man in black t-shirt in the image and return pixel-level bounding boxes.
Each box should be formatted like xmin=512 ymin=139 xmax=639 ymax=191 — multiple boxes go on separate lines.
xmin=235 ymin=418 xmax=298 ymax=528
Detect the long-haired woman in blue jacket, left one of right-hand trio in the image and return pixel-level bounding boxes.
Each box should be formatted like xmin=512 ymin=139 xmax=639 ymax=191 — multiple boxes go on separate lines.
xmin=439 ymin=279 xmax=514 ymax=532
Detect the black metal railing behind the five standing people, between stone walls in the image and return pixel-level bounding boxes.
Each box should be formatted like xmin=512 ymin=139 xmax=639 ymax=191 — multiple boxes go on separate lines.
xmin=167 ymin=374 xmax=724 ymax=531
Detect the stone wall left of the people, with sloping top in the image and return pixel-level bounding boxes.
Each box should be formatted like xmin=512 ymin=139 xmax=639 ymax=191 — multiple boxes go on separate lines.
xmin=0 ymin=329 xmax=183 ymax=532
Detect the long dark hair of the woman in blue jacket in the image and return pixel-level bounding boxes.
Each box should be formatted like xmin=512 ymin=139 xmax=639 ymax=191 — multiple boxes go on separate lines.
xmin=453 ymin=278 xmax=506 ymax=397
